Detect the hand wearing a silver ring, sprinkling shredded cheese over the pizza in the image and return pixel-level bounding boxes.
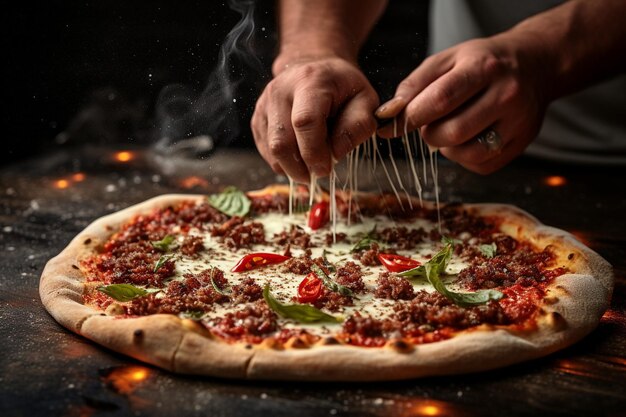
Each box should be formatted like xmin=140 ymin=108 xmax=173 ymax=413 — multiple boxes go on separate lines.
xmin=376 ymin=34 xmax=549 ymax=174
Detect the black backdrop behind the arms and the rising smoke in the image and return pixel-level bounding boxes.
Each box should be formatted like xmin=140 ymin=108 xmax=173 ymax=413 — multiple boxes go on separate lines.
xmin=0 ymin=0 xmax=427 ymax=164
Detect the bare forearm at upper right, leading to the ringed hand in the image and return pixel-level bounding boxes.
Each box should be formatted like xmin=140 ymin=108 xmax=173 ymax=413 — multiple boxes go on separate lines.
xmin=502 ymin=0 xmax=626 ymax=99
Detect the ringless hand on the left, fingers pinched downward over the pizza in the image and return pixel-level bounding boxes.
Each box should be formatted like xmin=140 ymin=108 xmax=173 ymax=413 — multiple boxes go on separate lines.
xmin=251 ymin=57 xmax=379 ymax=183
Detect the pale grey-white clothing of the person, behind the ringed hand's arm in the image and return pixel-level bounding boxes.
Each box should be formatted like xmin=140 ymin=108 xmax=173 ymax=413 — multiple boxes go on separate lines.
xmin=429 ymin=0 xmax=626 ymax=165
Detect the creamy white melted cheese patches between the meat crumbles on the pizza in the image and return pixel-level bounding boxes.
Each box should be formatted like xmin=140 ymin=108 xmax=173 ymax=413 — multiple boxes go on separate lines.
xmin=165 ymin=213 xmax=467 ymax=335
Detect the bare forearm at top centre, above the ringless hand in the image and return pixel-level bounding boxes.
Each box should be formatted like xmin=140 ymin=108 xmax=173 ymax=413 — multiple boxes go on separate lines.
xmin=273 ymin=0 xmax=387 ymax=75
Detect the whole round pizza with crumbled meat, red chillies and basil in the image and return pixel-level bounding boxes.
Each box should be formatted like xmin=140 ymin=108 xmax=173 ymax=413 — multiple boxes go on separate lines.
xmin=40 ymin=185 xmax=613 ymax=381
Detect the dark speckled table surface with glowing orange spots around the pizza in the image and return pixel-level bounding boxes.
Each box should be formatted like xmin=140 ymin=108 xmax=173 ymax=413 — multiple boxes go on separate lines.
xmin=0 ymin=148 xmax=626 ymax=416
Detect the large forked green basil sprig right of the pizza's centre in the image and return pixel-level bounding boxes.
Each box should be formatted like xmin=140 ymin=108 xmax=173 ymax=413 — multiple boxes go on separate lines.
xmin=398 ymin=238 xmax=503 ymax=307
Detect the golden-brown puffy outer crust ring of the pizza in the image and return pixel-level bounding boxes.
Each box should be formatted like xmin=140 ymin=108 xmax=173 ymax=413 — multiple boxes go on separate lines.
xmin=40 ymin=186 xmax=613 ymax=381
